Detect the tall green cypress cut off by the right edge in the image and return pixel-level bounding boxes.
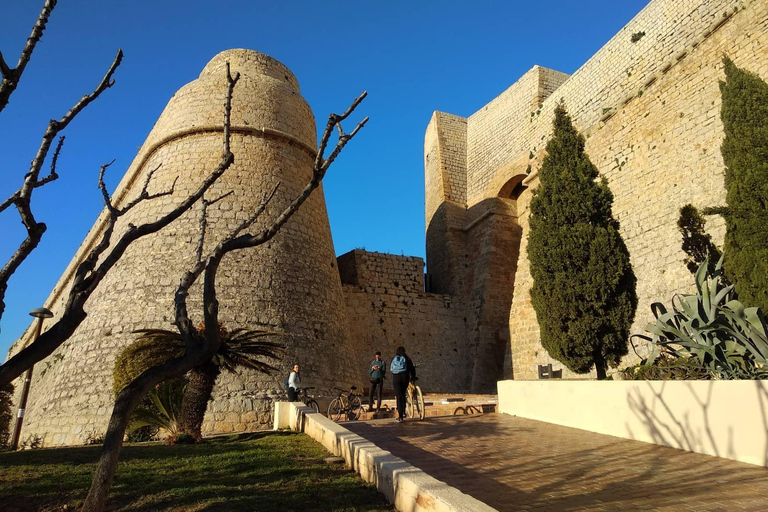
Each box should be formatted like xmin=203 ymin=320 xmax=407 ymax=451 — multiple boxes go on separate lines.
xmin=720 ymin=58 xmax=768 ymax=311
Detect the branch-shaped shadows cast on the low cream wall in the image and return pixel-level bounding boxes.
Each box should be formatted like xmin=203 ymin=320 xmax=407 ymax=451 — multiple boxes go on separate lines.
xmin=626 ymin=381 xmax=768 ymax=466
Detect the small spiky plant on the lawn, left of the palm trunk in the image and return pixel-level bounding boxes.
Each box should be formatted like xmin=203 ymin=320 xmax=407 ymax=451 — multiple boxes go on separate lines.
xmin=128 ymin=379 xmax=187 ymax=439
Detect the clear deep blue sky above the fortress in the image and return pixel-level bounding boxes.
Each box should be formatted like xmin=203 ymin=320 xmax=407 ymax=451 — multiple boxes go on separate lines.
xmin=0 ymin=0 xmax=648 ymax=359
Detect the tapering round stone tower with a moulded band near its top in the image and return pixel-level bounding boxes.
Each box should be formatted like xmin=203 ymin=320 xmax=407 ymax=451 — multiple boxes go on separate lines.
xmin=14 ymin=49 xmax=354 ymax=445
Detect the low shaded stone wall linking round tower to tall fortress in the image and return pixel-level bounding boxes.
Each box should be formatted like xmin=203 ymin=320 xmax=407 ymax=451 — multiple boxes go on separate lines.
xmin=339 ymin=250 xmax=472 ymax=392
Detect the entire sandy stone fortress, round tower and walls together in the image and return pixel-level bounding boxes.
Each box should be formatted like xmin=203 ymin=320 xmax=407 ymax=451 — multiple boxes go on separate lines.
xmin=11 ymin=0 xmax=768 ymax=445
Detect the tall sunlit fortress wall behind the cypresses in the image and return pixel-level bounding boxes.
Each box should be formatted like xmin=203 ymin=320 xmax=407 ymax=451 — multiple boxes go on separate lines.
xmin=425 ymin=0 xmax=768 ymax=378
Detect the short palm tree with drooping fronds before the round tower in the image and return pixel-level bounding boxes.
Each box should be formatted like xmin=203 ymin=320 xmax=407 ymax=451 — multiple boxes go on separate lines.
xmin=135 ymin=324 xmax=282 ymax=440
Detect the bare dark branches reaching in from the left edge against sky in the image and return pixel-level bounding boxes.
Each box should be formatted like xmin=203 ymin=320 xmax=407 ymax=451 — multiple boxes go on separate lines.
xmin=0 ymin=0 xmax=234 ymax=386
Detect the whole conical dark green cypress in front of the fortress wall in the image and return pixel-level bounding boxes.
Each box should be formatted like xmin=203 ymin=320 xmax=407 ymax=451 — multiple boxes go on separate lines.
xmin=528 ymin=105 xmax=637 ymax=379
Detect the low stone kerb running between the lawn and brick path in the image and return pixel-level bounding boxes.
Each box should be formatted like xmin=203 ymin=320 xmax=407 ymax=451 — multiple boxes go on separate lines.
xmin=274 ymin=402 xmax=496 ymax=512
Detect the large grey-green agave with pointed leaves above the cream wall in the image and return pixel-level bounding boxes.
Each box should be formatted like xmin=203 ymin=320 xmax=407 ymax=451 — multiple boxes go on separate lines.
xmin=633 ymin=257 xmax=768 ymax=379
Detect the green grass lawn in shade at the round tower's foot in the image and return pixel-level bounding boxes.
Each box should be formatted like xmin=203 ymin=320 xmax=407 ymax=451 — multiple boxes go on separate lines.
xmin=0 ymin=432 xmax=394 ymax=512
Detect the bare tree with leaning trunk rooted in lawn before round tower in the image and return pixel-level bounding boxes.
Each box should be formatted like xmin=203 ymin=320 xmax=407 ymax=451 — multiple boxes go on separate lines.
xmin=83 ymin=81 xmax=368 ymax=512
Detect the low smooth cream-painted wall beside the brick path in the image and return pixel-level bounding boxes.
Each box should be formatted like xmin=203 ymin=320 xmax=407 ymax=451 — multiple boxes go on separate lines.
xmin=498 ymin=380 xmax=768 ymax=467
